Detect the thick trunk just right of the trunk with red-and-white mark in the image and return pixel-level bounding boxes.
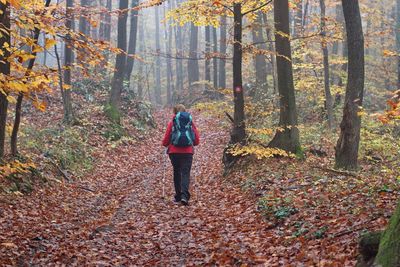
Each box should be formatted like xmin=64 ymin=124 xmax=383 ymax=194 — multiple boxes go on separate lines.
xmin=269 ymin=0 xmax=300 ymax=153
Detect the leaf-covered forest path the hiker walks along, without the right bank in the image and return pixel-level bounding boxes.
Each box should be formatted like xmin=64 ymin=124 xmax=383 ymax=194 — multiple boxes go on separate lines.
xmin=0 ymin=112 xmax=272 ymax=266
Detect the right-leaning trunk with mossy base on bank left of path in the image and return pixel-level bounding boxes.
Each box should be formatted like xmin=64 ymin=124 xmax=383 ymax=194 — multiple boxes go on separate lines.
xmin=106 ymin=0 xmax=128 ymax=123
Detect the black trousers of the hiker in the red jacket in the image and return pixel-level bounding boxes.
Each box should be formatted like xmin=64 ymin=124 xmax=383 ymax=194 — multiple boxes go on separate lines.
xmin=169 ymin=154 xmax=193 ymax=201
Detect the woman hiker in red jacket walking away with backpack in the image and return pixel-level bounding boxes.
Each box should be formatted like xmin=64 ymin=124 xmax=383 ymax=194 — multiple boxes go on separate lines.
xmin=162 ymin=105 xmax=200 ymax=206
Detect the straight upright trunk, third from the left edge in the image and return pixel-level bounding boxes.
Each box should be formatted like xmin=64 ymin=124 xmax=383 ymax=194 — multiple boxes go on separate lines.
xmin=63 ymin=0 xmax=74 ymax=124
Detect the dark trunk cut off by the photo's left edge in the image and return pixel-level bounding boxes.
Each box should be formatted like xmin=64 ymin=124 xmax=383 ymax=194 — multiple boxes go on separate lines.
xmin=0 ymin=2 xmax=11 ymax=160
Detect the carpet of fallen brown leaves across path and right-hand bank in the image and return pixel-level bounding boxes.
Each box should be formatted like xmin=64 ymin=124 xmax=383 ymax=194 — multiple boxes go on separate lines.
xmin=0 ymin=110 xmax=397 ymax=266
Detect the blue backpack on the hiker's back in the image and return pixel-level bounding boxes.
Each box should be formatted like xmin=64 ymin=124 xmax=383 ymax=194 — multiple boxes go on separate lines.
xmin=171 ymin=112 xmax=195 ymax=147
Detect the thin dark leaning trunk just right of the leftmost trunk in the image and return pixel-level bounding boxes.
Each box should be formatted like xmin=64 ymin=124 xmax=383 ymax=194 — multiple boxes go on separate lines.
xmin=11 ymin=0 xmax=51 ymax=156
